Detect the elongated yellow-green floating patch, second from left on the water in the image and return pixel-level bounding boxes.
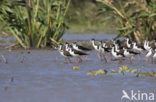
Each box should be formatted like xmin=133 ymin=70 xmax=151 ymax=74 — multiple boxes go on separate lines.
xmin=87 ymin=69 xmax=108 ymax=76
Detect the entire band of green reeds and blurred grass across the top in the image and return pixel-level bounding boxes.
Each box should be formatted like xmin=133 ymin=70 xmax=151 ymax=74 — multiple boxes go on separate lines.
xmin=0 ymin=0 xmax=156 ymax=48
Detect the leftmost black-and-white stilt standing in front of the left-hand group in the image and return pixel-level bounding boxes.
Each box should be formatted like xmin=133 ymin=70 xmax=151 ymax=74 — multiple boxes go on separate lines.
xmin=58 ymin=44 xmax=73 ymax=63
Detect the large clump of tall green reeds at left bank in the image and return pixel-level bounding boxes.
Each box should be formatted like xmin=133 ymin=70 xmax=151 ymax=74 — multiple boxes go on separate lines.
xmin=0 ymin=0 xmax=71 ymax=48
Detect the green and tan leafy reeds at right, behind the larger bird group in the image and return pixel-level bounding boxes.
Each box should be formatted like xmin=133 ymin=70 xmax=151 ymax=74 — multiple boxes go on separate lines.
xmin=96 ymin=0 xmax=156 ymax=43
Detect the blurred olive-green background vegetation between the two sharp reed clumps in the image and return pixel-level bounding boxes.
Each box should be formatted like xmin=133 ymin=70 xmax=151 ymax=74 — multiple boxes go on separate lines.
xmin=67 ymin=0 xmax=116 ymax=33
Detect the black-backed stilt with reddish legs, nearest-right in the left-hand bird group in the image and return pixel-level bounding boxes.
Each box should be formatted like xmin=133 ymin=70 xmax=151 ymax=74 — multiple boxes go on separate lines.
xmin=69 ymin=47 xmax=88 ymax=63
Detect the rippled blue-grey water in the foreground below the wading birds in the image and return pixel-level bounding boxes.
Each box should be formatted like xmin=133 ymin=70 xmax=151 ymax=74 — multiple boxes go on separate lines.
xmin=0 ymin=33 xmax=156 ymax=102
